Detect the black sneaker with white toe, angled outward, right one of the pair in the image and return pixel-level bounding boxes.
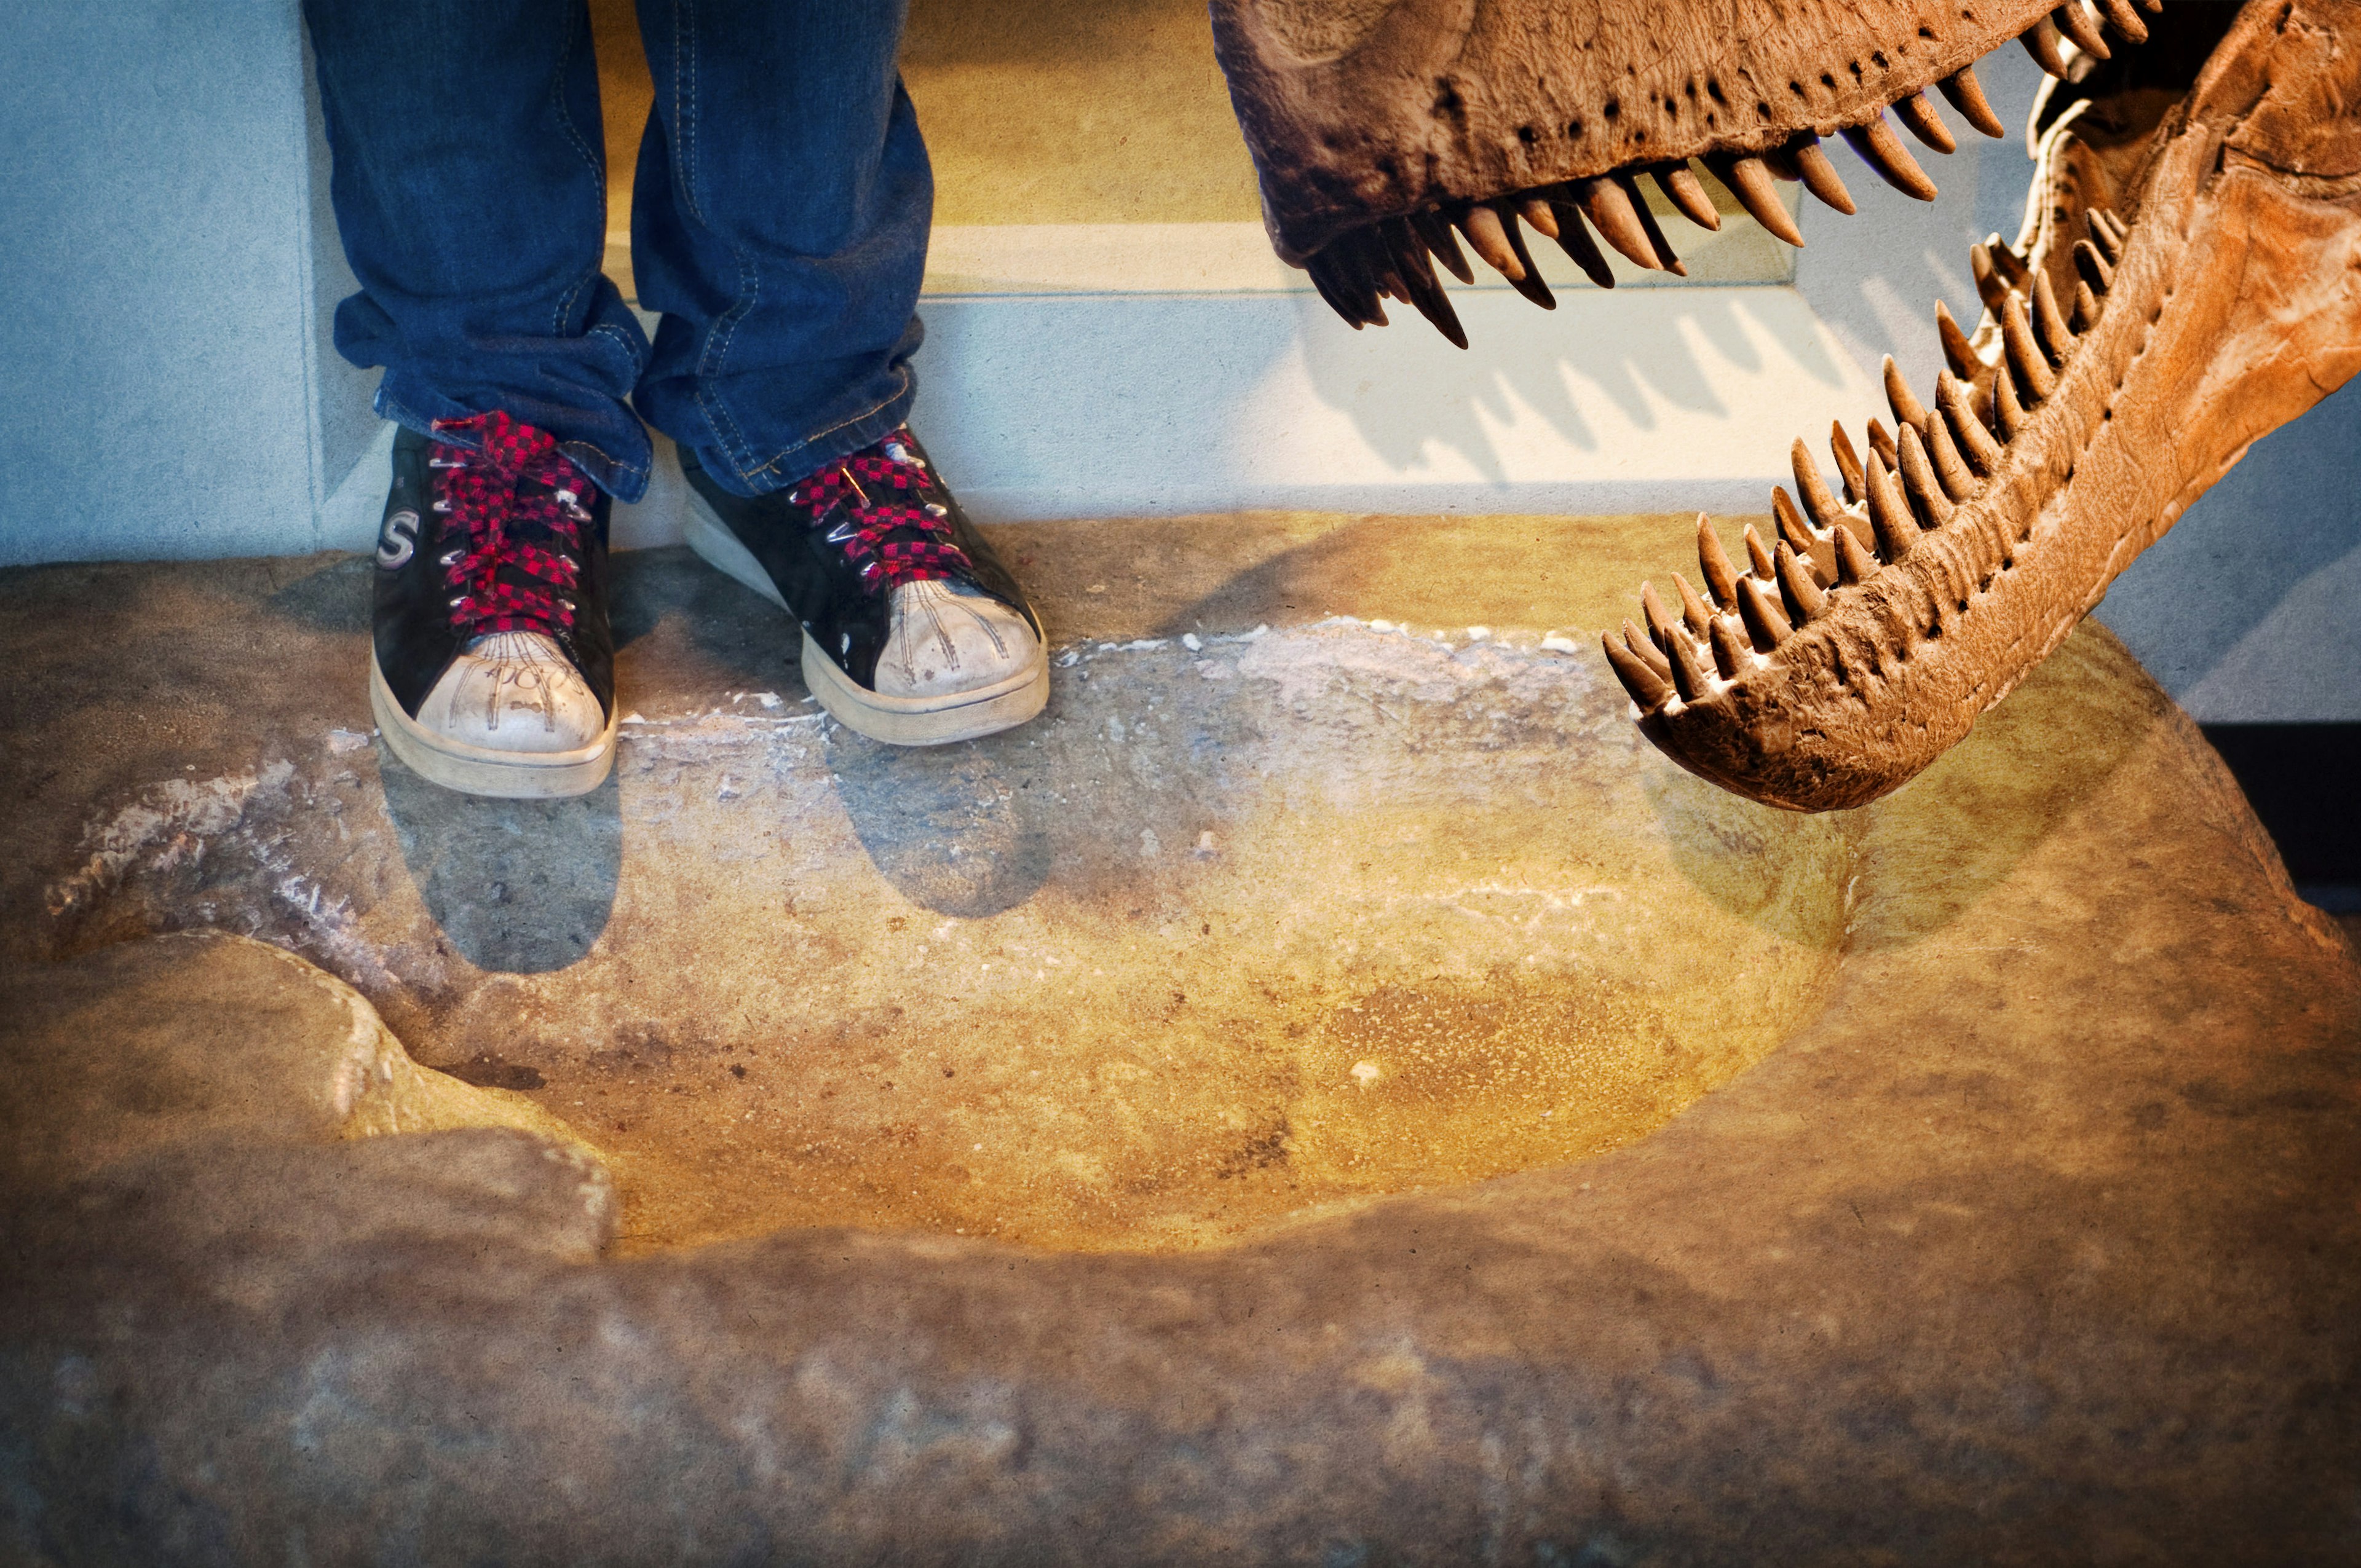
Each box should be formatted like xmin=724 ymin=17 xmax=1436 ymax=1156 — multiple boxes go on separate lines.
xmin=680 ymin=427 xmax=1048 ymax=746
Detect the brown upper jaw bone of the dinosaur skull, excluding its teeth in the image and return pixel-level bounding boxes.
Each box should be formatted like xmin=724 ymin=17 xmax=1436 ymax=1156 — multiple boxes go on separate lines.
xmin=1211 ymin=0 xmax=2068 ymax=262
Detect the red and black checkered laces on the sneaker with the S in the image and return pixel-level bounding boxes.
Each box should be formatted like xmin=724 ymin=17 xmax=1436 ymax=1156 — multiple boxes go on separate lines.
xmin=427 ymin=411 xmax=590 ymax=633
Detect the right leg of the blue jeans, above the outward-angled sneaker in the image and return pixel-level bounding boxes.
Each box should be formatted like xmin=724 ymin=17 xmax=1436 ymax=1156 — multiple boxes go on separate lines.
xmin=630 ymin=0 xmax=935 ymax=496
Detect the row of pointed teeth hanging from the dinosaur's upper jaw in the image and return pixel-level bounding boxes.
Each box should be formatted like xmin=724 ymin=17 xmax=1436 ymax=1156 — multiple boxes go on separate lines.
xmin=1306 ymin=0 xmax=2162 ymax=347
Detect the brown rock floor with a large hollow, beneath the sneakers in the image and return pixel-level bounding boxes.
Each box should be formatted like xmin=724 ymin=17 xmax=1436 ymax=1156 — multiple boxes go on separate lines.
xmin=0 ymin=517 xmax=2361 ymax=1561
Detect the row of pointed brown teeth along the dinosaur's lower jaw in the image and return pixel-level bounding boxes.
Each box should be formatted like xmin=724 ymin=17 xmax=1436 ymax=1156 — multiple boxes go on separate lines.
xmin=1603 ymin=208 xmax=2127 ymax=713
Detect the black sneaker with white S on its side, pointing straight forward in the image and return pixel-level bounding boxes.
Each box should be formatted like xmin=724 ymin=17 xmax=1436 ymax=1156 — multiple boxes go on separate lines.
xmin=368 ymin=413 xmax=616 ymax=798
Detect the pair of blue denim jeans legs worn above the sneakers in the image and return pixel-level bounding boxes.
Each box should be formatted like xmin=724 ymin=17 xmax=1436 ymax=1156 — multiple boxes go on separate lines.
xmin=304 ymin=0 xmax=935 ymax=500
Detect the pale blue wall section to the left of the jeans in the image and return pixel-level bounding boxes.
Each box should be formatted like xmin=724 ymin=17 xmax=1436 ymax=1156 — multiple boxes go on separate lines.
xmin=0 ymin=0 xmax=371 ymax=564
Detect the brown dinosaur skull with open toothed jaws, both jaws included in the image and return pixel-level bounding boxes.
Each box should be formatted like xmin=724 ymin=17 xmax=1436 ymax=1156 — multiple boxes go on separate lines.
xmin=1214 ymin=0 xmax=2361 ymax=810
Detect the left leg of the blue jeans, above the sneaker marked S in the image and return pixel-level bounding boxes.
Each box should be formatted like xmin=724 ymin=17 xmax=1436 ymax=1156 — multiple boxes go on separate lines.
xmin=303 ymin=0 xmax=649 ymax=500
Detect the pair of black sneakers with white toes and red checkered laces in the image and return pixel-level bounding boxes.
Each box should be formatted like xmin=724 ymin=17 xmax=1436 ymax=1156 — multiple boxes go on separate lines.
xmin=368 ymin=413 xmax=1048 ymax=798
